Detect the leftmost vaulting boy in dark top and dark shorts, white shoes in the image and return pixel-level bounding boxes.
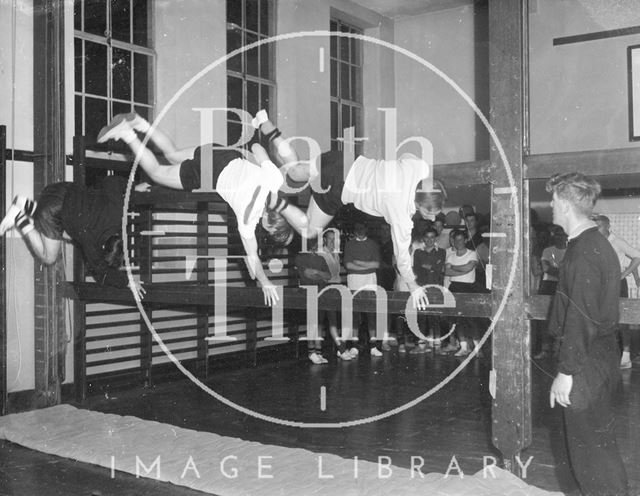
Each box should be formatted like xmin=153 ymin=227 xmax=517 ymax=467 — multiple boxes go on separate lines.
xmin=0 ymin=176 xmax=145 ymax=297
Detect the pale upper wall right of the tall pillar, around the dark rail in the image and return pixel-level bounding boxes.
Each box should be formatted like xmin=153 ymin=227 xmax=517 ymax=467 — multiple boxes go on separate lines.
xmin=529 ymin=0 xmax=640 ymax=153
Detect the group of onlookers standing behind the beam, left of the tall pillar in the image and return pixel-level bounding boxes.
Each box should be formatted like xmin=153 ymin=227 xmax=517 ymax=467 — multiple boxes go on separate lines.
xmin=295 ymin=205 xmax=489 ymax=364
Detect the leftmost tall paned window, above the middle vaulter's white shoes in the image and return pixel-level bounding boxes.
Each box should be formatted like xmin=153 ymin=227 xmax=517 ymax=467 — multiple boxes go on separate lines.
xmin=74 ymin=0 xmax=153 ymax=138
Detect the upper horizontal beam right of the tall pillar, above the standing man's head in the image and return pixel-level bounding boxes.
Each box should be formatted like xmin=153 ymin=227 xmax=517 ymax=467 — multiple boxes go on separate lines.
xmin=525 ymin=146 xmax=640 ymax=179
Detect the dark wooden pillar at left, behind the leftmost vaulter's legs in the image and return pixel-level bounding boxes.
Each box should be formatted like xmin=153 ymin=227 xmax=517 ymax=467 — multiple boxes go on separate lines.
xmin=33 ymin=0 xmax=66 ymax=406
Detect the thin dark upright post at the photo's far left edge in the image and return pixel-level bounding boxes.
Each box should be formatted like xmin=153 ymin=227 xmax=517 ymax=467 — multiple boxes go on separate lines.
xmin=0 ymin=126 xmax=7 ymax=415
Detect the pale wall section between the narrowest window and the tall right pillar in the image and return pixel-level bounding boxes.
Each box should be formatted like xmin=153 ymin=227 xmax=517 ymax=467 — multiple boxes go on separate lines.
xmin=395 ymin=6 xmax=477 ymax=163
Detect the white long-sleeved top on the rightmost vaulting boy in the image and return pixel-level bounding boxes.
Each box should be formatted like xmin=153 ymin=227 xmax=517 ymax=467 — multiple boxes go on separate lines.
xmin=341 ymin=154 xmax=431 ymax=281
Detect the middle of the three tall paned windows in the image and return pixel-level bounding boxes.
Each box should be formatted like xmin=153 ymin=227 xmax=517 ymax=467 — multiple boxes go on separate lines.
xmin=227 ymin=0 xmax=276 ymax=144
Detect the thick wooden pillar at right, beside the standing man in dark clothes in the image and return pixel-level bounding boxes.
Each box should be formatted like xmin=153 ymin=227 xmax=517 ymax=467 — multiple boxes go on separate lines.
xmin=489 ymin=0 xmax=531 ymax=472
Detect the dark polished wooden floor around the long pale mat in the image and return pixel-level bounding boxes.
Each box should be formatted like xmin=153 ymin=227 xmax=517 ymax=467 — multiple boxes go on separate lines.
xmin=0 ymin=348 xmax=640 ymax=496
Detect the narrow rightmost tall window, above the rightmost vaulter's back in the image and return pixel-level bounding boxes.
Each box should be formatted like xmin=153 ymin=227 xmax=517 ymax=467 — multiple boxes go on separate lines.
xmin=330 ymin=19 xmax=363 ymax=156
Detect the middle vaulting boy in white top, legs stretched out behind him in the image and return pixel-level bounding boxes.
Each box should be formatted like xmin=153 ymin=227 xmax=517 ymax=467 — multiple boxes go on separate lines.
xmin=98 ymin=113 xmax=293 ymax=306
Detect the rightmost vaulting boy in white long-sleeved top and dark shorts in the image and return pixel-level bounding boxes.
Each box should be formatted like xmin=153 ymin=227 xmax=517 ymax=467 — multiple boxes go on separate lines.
xmin=252 ymin=110 xmax=446 ymax=309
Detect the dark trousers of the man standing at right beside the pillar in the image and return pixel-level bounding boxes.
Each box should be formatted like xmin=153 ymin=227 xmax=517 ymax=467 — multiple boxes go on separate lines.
xmin=564 ymin=387 xmax=629 ymax=496
